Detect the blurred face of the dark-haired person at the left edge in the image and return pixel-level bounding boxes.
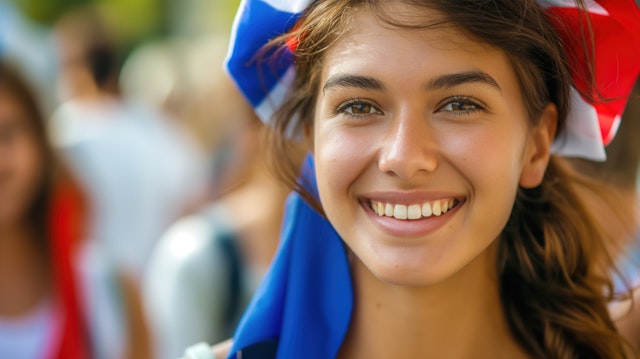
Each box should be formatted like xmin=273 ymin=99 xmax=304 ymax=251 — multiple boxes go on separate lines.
xmin=0 ymin=88 xmax=42 ymax=229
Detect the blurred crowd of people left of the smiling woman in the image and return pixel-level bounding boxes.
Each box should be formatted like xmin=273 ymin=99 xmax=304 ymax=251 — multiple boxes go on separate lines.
xmin=0 ymin=0 xmax=302 ymax=359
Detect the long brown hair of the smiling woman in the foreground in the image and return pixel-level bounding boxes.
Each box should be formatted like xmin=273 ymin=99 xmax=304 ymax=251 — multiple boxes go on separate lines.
xmin=268 ymin=0 xmax=626 ymax=358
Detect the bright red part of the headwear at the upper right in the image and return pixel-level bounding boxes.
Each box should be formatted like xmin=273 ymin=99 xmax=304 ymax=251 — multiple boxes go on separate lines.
xmin=547 ymin=0 xmax=640 ymax=145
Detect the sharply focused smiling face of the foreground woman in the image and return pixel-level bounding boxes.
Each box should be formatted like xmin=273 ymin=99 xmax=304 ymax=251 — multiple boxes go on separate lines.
xmin=313 ymin=4 xmax=553 ymax=285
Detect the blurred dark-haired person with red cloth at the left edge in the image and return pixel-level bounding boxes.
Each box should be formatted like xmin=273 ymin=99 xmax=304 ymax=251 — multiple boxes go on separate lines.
xmin=0 ymin=61 xmax=94 ymax=359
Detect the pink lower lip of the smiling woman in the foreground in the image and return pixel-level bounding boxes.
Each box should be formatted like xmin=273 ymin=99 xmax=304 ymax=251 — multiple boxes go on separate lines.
xmin=362 ymin=202 xmax=464 ymax=237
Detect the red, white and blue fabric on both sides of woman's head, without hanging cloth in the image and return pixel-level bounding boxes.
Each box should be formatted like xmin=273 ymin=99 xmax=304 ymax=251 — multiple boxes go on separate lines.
xmin=226 ymin=0 xmax=640 ymax=160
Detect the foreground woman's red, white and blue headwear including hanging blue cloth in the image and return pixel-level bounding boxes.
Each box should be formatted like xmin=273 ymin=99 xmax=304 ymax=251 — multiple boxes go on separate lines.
xmin=226 ymin=0 xmax=640 ymax=359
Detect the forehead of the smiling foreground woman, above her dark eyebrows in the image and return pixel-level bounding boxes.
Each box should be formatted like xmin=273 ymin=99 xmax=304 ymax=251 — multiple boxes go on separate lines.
xmin=322 ymin=1 xmax=515 ymax=88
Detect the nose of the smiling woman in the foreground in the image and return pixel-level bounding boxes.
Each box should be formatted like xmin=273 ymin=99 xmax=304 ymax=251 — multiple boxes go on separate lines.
xmin=378 ymin=113 xmax=438 ymax=180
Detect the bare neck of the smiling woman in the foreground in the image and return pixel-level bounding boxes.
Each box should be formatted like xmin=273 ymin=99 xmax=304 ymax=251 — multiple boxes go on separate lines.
xmin=340 ymin=242 xmax=526 ymax=359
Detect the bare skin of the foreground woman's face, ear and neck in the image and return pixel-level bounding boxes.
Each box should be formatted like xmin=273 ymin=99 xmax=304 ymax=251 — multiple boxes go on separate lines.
xmin=312 ymin=2 xmax=557 ymax=358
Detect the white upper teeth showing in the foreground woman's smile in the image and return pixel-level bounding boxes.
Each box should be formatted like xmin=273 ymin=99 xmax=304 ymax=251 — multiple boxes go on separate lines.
xmin=369 ymin=198 xmax=460 ymax=220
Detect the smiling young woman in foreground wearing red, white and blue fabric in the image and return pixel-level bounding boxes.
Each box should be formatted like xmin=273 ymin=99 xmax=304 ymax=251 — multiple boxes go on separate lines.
xmin=187 ymin=0 xmax=640 ymax=359
